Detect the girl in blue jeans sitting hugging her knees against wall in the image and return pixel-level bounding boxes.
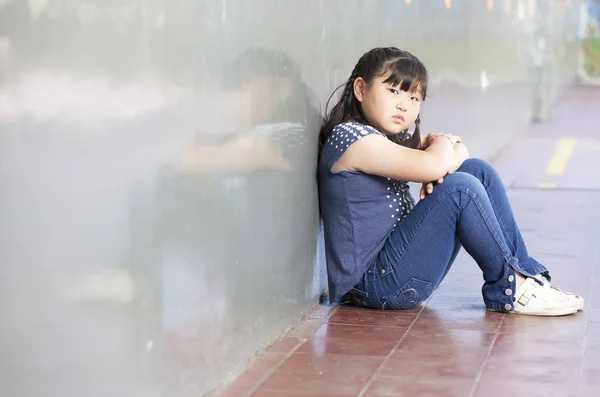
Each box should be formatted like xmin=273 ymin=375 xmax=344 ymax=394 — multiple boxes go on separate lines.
xmin=319 ymin=47 xmax=584 ymax=316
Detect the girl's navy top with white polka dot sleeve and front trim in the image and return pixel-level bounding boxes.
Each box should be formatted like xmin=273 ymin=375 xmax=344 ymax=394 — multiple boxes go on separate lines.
xmin=319 ymin=122 xmax=414 ymax=303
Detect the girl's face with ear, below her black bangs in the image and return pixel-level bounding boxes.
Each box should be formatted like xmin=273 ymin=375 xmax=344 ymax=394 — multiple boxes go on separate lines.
xmin=354 ymin=74 xmax=422 ymax=134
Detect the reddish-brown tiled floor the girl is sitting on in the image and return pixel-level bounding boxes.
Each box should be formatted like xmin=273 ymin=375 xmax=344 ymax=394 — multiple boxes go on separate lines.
xmin=214 ymin=89 xmax=600 ymax=397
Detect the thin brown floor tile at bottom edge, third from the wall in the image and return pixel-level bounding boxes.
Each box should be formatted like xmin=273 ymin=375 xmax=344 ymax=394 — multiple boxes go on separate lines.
xmin=364 ymin=376 xmax=475 ymax=397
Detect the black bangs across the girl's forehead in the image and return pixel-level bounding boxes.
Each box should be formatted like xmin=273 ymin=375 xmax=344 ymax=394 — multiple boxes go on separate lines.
xmin=384 ymin=58 xmax=429 ymax=100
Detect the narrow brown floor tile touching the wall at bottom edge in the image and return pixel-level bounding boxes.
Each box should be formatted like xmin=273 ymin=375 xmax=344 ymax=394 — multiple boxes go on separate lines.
xmin=215 ymin=353 xmax=287 ymax=397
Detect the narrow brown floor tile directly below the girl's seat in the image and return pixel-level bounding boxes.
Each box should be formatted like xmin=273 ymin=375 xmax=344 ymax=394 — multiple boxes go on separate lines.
xmin=328 ymin=310 xmax=417 ymax=327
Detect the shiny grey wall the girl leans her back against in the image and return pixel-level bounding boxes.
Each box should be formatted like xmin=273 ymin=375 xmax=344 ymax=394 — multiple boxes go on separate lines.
xmin=0 ymin=0 xmax=574 ymax=397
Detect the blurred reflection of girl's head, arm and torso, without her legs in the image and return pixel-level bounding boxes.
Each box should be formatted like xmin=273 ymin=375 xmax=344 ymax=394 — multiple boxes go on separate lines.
xmin=181 ymin=49 xmax=321 ymax=304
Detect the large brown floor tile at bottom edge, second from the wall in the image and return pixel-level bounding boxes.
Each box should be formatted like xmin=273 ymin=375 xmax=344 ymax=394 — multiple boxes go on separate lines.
xmin=260 ymin=353 xmax=384 ymax=395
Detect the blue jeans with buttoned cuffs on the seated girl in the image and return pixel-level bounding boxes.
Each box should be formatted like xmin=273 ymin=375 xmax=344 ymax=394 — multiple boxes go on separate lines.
xmin=348 ymin=159 xmax=550 ymax=310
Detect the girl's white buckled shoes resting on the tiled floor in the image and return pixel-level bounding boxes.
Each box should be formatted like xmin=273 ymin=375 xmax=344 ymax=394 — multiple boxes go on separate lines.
xmin=509 ymin=277 xmax=583 ymax=316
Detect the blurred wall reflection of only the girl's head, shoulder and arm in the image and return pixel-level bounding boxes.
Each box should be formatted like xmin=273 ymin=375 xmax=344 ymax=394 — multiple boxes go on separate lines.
xmin=181 ymin=49 xmax=319 ymax=174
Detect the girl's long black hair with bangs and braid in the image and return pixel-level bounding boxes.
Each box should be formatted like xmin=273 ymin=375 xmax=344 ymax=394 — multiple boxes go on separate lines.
xmin=319 ymin=47 xmax=429 ymax=149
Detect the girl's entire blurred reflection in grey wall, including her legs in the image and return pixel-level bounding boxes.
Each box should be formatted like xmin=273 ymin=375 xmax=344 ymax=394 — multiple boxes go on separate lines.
xmin=160 ymin=50 xmax=320 ymax=386
